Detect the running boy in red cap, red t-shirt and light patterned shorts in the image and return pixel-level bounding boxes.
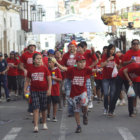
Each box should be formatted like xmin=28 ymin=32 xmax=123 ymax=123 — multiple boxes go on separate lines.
xmin=52 ymin=55 xmax=101 ymax=133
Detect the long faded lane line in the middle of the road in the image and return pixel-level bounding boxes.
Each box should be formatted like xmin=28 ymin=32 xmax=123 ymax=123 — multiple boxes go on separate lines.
xmin=59 ymin=107 xmax=67 ymax=140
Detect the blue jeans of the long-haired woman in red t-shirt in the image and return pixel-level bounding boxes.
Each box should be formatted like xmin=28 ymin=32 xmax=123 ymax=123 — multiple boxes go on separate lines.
xmin=102 ymin=78 xmax=116 ymax=110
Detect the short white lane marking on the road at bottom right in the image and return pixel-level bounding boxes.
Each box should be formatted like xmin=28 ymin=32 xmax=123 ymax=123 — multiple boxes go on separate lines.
xmin=117 ymin=127 xmax=136 ymax=140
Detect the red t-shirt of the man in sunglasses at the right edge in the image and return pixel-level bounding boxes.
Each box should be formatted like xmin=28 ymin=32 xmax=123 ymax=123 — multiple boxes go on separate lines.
xmin=122 ymin=50 xmax=140 ymax=82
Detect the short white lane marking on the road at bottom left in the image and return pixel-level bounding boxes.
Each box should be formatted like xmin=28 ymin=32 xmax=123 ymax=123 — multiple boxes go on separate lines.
xmin=2 ymin=127 xmax=22 ymax=140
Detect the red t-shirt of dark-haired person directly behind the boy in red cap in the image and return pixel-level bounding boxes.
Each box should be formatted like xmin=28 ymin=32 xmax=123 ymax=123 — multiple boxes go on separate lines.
xmin=83 ymin=50 xmax=97 ymax=67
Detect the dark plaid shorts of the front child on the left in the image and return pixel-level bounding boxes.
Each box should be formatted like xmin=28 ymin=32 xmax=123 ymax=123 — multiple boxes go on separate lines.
xmin=31 ymin=91 xmax=47 ymax=111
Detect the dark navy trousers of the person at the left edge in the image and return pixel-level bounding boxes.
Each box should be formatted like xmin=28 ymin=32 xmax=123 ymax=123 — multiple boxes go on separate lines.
xmin=0 ymin=74 xmax=9 ymax=98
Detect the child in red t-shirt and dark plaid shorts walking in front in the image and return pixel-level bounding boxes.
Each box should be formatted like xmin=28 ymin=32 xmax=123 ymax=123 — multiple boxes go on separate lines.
xmin=24 ymin=53 xmax=51 ymax=132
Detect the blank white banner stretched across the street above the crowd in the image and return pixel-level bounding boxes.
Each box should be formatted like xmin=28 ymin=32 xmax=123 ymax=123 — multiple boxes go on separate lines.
xmin=32 ymin=19 xmax=107 ymax=34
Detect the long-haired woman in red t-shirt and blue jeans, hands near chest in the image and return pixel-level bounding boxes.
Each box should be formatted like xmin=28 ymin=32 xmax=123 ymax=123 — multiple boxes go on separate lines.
xmin=101 ymin=44 xmax=119 ymax=115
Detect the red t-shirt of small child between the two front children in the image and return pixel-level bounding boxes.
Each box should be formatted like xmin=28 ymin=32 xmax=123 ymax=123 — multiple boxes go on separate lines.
xmin=49 ymin=68 xmax=62 ymax=96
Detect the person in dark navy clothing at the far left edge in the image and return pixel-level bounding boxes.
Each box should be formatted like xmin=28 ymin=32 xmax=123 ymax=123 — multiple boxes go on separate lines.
xmin=0 ymin=52 xmax=10 ymax=102
